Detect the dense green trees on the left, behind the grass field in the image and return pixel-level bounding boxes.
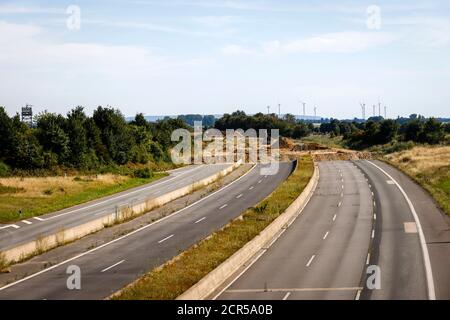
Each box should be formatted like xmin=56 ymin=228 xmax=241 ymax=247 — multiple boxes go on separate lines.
xmin=0 ymin=106 xmax=188 ymax=170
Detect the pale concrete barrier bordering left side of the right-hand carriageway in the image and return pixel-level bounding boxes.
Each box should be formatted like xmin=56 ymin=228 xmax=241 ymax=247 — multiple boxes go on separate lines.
xmin=177 ymin=165 xmax=319 ymax=300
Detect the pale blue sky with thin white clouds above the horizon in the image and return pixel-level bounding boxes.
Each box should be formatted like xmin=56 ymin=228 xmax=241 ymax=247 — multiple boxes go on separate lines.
xmin=0 ymin=0 xmax=450 ymax=118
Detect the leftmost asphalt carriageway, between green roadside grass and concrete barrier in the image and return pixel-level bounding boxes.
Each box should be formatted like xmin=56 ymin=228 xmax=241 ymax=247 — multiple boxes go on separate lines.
xmin=0 ymin=164 xmax=230 ymax=251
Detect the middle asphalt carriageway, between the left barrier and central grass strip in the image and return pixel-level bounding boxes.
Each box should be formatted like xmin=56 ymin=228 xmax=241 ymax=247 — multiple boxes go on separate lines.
xmin=0 ymin=163 xmax=293 ymax=299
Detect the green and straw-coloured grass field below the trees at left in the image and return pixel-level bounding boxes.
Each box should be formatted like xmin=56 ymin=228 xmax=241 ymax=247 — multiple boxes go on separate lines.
xmin=0 ymin=173 xmax=166 ymax=223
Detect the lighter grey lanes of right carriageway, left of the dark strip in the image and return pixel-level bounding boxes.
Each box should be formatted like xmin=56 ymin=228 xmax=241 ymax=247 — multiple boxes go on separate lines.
xmin=214 ymin=162 xmax=373 ymax=300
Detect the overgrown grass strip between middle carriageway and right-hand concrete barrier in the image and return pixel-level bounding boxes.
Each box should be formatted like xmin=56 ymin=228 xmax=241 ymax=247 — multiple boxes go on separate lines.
xmin=114 ymin=157 xmax=314 ymax=300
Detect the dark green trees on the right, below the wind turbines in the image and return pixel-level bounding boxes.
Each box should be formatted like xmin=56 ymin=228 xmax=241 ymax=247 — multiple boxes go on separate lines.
xmin=319 ymin=114 xmax=450 ymax=149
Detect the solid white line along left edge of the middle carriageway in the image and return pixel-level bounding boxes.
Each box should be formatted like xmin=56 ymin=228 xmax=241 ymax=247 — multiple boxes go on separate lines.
xmin=0 ymin=164 xmax=257 ymax=291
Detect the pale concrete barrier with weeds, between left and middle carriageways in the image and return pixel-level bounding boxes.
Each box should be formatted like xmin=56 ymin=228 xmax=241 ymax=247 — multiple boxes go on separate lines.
xmin=0 ymin=160 xmax=242 ymax=264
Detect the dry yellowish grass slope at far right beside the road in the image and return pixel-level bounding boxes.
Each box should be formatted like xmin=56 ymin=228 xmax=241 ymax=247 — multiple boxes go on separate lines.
xmin=385 ymin=146 xmax=450 ymax=215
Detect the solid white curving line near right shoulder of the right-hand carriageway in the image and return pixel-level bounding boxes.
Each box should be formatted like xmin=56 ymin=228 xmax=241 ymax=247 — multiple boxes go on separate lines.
xmin=367 ymin=161 xmax=436 ymax=300
